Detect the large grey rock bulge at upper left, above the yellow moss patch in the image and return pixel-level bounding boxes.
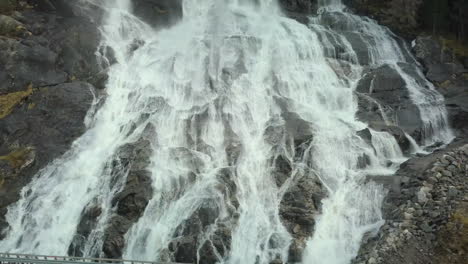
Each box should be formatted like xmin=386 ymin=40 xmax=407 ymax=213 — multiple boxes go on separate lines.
xmin=0 ymin=7 xmax=99 ymax=94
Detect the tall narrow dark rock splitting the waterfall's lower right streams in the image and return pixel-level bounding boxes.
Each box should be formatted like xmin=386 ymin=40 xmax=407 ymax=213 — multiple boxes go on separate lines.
xmin=264 ymin=111 xmax=326 ymax=262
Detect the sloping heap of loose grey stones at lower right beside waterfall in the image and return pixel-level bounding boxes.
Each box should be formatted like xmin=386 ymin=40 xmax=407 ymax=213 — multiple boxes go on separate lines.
xmin=355 ymin=140 xmax=468 ymax=264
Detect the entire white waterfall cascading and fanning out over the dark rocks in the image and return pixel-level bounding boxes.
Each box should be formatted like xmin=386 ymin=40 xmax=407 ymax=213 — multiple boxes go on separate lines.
xmin=0 ymin=0 xmax=451 ymax=264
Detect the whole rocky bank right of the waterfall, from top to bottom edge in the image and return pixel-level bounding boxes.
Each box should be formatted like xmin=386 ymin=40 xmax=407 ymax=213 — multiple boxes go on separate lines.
xmin=347 ymin=0 xmax=468 ymax=264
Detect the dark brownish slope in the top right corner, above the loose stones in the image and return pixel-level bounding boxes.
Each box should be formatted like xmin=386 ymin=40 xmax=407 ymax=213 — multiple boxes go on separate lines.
xmin=345 ymin=0 xmax=468 ymax=137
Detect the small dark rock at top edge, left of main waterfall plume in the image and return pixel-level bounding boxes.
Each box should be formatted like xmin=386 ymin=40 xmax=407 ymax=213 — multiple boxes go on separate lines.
xmin=132 ymin=0 xmax=182 ymax=27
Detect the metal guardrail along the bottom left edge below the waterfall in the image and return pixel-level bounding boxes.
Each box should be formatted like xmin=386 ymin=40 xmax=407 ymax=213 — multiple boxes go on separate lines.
xmin=0 ymin=253 xmax=188 ymax=264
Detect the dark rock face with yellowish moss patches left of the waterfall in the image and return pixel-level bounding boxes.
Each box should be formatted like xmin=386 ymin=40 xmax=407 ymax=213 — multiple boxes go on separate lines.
xmin=0 ymin=1 xmax=99 ymax=235
